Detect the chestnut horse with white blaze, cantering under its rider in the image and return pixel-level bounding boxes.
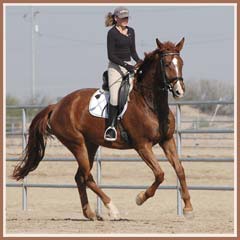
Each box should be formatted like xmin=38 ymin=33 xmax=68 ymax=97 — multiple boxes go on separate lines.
xmin=12 ymin=38 xmax=193 ymax=220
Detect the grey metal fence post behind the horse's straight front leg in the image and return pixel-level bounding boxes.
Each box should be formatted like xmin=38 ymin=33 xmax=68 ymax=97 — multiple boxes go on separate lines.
xmin=176 ymin=104 xmax=183 ymax=216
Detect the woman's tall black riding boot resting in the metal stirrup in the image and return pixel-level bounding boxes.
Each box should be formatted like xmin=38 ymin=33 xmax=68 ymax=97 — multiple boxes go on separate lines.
xmin=104 ymin=104 xmax=118 ymax=141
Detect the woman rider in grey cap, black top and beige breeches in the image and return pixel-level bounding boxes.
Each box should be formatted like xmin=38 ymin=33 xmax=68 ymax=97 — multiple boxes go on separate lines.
xmin=104 ymin=7 xmax=142 ymax=141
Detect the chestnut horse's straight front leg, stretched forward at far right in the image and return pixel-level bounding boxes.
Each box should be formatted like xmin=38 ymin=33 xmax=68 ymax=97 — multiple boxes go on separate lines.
xmin=160 ymin=138 xmax=193 ymax=214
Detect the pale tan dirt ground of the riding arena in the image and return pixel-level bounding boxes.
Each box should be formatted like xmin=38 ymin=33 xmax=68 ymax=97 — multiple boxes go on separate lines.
xmin=5 ymin=106 xmax=234 ymax=235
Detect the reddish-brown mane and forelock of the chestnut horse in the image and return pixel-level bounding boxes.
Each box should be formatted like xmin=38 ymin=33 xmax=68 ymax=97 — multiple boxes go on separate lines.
xmin=137 ymin=41 xmax=176 ymax=81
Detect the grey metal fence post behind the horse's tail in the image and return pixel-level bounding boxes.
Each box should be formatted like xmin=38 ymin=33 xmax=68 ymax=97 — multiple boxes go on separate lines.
xmin=22 ymin=108 xmax=27 ymax=211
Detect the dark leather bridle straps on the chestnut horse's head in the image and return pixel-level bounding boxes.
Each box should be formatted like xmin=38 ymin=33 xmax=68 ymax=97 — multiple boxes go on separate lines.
xmin=159 ymin=53 xmax=183 ymax=92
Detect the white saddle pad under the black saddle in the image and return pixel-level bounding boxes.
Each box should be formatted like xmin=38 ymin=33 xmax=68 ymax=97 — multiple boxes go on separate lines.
xmin=89 ymin=89 xmax=128 ymax=118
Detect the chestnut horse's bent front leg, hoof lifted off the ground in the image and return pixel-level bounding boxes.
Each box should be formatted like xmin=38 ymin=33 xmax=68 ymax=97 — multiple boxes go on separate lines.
xmin=136 ymin=143 xmax=164 ymax=205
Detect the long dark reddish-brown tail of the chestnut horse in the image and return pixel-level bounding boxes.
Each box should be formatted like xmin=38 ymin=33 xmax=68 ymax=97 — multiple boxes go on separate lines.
xmin=12 ymin=105 xmax=55 ymax=181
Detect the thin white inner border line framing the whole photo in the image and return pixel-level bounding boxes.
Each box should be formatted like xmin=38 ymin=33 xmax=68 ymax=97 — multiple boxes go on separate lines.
xmin=3 ymin=3 xmax=237 ymax=237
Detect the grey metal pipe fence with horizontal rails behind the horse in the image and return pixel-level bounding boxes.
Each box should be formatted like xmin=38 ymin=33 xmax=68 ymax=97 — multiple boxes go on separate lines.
xmin=6 ymin=101 xmax=236 ymax=215
